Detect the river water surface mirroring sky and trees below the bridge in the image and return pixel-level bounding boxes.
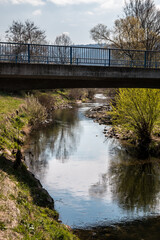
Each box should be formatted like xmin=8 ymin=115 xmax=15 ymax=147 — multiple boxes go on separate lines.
xmin=25 ymin=95 xmax=160 ymax=236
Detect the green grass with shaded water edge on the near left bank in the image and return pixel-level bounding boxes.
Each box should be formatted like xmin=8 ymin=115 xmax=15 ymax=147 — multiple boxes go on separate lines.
xmin=0 ymin=156 xmax=78 ymax=240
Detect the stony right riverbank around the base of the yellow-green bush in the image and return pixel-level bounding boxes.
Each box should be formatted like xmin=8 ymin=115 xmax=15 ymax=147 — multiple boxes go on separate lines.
xmin=86 ymin=101 xmax=160 ymax=157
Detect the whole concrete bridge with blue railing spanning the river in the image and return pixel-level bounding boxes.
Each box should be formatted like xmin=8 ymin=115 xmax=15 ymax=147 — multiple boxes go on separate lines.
xmin=0 ymin=42 xmax=160 ymax=90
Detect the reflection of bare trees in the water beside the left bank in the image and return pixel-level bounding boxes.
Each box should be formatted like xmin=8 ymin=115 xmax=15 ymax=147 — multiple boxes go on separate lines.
xmin=25 ymin=109 xmax=80 ymax=175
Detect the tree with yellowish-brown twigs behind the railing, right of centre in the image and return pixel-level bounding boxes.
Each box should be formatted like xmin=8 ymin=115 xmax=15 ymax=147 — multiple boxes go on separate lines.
xmin=91 ymin=17 xmax=144 ymax=66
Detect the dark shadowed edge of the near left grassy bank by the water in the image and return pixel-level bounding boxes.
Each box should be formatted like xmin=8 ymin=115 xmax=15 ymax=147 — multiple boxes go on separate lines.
xmin=0 ymin=156 xmax=58 ymax=219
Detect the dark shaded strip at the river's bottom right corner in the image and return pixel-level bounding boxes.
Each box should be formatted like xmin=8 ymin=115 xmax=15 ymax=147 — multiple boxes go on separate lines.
xmin=74 ymin=217 xmax=160 ymax=240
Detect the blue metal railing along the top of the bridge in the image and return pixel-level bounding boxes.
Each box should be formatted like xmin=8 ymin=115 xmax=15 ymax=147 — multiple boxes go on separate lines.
xmin=0 ymin=42 xmax=160 ymax=68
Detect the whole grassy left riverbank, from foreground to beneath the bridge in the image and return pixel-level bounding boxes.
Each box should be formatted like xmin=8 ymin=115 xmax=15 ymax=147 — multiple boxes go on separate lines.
xmin=0 ymin=91 xmax=78 ymax=240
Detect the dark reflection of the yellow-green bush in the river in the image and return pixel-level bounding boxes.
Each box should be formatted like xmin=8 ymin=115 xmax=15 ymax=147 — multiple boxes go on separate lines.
xmin=109 ymin=146 xmax=160 ymax=212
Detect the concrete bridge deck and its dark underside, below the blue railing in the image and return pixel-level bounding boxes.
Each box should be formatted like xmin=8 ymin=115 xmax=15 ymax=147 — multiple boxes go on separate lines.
xmin=0 ymin=63 xmax=160 ymax=90
